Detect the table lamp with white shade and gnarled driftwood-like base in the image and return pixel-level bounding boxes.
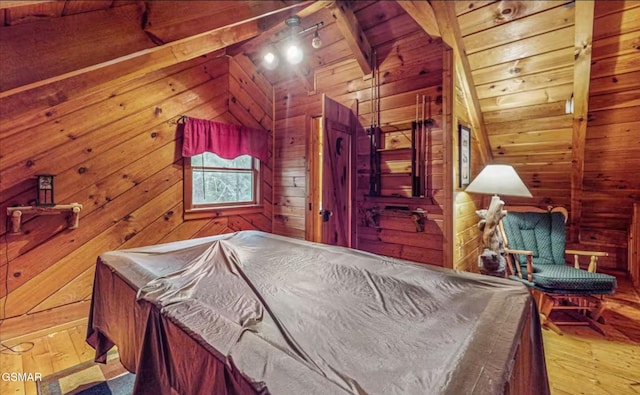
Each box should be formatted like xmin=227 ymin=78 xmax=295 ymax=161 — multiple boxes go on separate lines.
xmin=465 ymin=165 xmax=532 ymax=277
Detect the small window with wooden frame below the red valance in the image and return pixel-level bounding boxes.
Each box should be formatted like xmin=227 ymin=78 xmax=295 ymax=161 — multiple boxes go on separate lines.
xmin=184 ymin=152 xmax=260 ymax=219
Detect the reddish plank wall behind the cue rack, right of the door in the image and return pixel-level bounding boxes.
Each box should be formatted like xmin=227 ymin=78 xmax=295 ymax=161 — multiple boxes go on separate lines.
xmin=356 ymin=38 xmax=450 ymax=266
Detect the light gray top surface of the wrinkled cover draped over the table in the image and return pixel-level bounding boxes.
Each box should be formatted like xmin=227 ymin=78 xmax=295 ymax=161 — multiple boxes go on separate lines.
xmin=101 ymin=231 xmax=548 ymax=394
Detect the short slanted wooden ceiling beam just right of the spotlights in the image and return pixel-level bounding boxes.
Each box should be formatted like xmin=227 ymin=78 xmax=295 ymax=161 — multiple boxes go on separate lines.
xmin=331 ymin=1 xmax=373 ymax=75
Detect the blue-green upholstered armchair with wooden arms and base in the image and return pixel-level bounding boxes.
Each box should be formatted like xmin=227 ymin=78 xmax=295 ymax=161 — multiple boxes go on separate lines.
xmin=500 ymin=207 xmax=616 ymax=333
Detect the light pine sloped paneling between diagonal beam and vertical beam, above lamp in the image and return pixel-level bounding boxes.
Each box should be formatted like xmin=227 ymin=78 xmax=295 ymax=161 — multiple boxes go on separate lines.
xmin=456 ymin=1 xmax=575 ymax=235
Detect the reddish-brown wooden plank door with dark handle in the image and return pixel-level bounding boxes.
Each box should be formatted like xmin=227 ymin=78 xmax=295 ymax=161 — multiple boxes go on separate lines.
xmin=318 ymin=95 xmax=355 ymax=247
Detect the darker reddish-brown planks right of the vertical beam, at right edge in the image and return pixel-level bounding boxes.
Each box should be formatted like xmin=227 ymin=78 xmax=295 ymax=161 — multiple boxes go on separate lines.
xmin=578 ymin=1 xmax=640 ymax=270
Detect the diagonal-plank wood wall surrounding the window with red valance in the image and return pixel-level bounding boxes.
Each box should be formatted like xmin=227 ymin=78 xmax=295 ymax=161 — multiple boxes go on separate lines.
xmin=0 ymin=56 xmax=273 ymax=338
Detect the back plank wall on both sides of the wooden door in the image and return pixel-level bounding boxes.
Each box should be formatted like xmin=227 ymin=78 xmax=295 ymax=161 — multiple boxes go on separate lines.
xmin=274 ymin=25 xmax=444 ymax=265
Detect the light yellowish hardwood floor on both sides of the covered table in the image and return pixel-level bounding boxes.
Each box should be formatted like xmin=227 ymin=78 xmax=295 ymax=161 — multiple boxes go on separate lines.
xmin=0 ymin=276 xmax=640 ymax=395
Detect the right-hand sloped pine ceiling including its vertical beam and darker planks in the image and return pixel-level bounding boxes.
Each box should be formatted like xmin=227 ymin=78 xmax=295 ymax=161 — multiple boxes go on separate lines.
xmin=432 ymin=1 xmax=640 ymax=251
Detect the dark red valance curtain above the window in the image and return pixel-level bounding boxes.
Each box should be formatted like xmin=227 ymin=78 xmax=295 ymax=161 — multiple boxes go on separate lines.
xmin=182 ymin=118 xmax=269 ymax=161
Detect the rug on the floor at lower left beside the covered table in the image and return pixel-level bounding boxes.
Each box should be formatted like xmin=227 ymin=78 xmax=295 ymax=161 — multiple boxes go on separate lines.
xmin=38 ymin=352 xmax=135 ymax=395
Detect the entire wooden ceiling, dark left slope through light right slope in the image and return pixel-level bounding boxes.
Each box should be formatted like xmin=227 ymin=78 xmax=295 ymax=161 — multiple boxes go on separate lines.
xmin=0 ymin=0 xmax=640 ymax=252
